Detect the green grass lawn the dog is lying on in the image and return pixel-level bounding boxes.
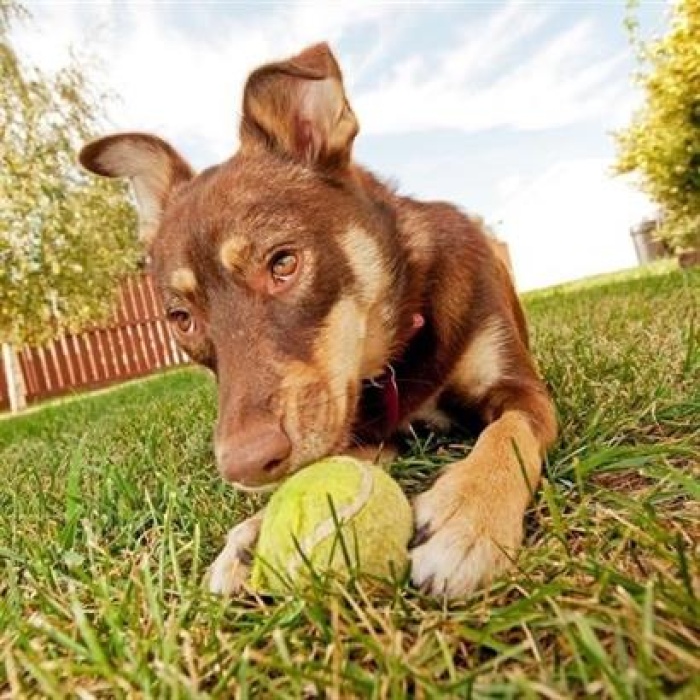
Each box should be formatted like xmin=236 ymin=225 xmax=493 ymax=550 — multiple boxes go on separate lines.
xmin=0 ymin=270 xmax=700 ymax=698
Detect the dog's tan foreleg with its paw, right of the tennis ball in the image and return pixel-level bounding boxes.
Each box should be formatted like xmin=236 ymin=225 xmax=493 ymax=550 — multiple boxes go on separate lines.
xmin=411 ymin=379 xmax=555 ymax=598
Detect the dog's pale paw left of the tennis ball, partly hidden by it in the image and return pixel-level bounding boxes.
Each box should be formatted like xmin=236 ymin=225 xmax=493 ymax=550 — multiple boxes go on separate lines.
xmin=208 ymin=513 xmax=262 ymax=596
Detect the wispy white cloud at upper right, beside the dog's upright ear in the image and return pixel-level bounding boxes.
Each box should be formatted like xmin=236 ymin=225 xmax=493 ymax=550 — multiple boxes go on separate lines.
xmin=355 ymin=8 xmax=629 ymax=134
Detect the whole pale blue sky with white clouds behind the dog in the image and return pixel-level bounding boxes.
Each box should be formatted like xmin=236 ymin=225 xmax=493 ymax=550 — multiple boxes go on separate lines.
xmin=13 ymin=0 xmax=668 ymax=291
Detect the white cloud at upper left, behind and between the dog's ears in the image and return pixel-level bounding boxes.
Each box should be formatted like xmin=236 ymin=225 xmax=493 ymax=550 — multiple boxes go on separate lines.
xmin=14 ymin=0 xmax=402 ymax=165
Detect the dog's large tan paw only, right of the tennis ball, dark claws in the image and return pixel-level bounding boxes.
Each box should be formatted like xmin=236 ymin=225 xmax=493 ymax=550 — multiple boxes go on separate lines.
xmin=404 ymin=473 xmax=524 ymax=598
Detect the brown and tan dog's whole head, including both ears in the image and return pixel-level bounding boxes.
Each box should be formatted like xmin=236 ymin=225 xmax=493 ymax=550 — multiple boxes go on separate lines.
xmin=80 ymin=45 xmax=394 ymax=488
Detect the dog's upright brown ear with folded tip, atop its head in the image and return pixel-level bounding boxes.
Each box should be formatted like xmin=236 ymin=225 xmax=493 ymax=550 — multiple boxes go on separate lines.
xmin=241 ymin=44 xmax=359 ymax=169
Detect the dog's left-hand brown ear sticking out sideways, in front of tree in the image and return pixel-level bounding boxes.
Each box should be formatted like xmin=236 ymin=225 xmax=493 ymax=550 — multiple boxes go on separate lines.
xmin=79 ymin=134 xmax=194 ymax=244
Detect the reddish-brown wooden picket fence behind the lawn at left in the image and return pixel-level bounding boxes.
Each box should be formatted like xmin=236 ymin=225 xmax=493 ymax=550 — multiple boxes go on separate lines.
xmin=0 ymin=275 xmax=188 ymax=409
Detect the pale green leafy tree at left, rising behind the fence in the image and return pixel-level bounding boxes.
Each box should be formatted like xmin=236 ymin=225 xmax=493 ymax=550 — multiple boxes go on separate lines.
xmin=0 ymin=0 xmax=138 ymax=345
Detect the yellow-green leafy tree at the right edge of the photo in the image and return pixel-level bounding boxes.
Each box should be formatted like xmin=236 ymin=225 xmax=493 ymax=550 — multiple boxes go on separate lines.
xmin=616 ymin=0 xmax=700 ymax=248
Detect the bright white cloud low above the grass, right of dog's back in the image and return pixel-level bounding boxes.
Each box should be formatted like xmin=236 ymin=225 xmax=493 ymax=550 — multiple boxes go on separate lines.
xmin=494 ymin=158 xmax=654 ymax=290
